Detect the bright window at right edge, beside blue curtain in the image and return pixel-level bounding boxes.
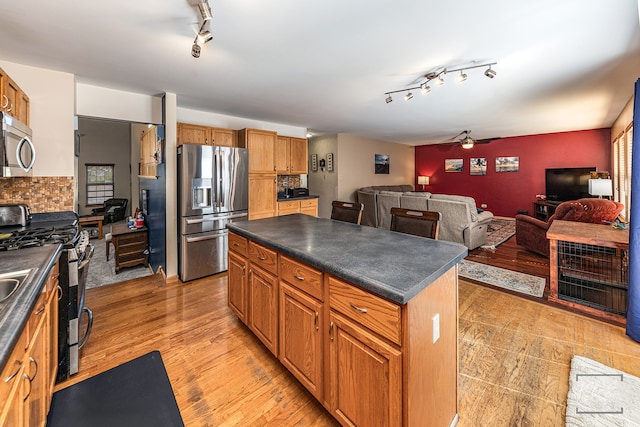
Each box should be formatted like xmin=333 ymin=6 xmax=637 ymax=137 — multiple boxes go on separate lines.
xmin=613 ymin=124 xmax=633 ymax=221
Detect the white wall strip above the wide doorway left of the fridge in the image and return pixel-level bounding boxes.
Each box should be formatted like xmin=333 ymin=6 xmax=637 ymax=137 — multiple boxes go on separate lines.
xmin=76 ymin=83 xmax=162 ymax=124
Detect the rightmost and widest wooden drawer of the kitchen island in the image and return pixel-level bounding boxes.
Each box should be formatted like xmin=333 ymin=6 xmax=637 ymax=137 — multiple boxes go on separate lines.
xmin=329 ymin=277 xmax=402 ymax=345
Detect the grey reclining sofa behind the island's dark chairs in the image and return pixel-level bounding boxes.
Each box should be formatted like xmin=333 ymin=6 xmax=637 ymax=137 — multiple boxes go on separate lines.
xmin=357 ymin=185 xmax=493 ymax=250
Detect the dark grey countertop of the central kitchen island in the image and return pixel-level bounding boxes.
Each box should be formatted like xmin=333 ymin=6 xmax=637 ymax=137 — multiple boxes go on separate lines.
xmin=227 ymin=214 xmax=467 ymax=304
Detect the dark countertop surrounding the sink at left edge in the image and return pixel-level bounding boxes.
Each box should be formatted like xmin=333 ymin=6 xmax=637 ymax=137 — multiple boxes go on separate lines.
xmin=0 ymin=244 xmax=62 ymax=371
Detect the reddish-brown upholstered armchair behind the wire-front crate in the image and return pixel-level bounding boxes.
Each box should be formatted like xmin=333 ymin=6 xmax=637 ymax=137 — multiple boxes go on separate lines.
xmin=516 ymin=199 xmax=624 ymax=257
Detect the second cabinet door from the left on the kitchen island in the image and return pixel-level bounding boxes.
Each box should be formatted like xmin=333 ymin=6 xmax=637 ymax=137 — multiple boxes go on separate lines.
xmin=249 ymin=264 xmax=278 ymax=357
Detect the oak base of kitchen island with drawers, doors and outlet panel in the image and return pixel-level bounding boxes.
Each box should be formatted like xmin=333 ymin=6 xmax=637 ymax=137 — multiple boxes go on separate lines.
xmin=229 ymin=233 xmax=458 ymax=427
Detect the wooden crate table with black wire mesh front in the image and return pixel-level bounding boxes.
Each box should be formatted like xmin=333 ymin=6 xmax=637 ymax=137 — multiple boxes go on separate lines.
xmin=547 ymin=220 xmax=629 ymax=325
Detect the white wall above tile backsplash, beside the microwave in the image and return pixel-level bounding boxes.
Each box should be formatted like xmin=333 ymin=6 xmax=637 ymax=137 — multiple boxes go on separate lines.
xmin=0 ymin=61 xmax=75 ymax=176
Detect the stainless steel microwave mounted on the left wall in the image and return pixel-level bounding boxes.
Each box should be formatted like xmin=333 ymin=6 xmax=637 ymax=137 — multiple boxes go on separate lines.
xmin=0 ymin=112 xmax=36 ymax=177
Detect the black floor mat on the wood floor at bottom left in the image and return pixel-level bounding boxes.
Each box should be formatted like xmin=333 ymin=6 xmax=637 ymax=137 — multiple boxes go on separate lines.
xmin=47 ymin=351 xmax=184 ymax=427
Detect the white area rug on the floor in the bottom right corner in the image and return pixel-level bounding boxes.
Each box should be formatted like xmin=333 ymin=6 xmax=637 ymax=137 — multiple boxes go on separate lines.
xmin=566 ymin=356 xmax=640 ymax=427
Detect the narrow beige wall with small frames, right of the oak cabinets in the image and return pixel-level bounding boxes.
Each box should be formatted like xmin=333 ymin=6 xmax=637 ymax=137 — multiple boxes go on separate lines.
xmin=308 ymin=135 xmax=340 ymax=218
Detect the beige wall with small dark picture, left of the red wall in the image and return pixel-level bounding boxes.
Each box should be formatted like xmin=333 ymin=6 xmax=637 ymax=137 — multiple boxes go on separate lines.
xmin=336 ymin=133 xmax=415 ymax=201
